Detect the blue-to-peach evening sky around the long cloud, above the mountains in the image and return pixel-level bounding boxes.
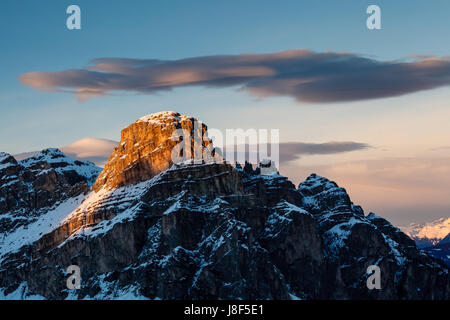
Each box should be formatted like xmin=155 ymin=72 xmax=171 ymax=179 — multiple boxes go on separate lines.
xmin=0 ymin=0 xmax=450 ymax=224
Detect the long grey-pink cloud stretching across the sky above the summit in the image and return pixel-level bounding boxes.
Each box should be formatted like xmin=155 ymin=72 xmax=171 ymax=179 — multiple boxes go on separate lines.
xmin=19 ymin=50 xmax=450 ymax=103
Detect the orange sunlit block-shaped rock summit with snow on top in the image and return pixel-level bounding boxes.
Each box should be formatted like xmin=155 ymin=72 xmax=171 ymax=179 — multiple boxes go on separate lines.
xmin=93 ymin=111 xmax=212 ymax=191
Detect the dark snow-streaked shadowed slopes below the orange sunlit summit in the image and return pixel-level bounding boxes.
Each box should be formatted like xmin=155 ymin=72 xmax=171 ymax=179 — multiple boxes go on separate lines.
xmin=0 ymin=163 xmax=450 ymax=299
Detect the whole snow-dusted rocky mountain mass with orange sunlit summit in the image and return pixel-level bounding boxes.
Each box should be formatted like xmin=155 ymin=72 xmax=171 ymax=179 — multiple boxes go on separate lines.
xmin=0 ymin=112 xmax=450 ymax=300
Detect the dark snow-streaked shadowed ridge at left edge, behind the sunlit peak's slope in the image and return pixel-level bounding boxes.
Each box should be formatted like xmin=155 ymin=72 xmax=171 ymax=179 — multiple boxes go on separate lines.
xmin=0 ymin=149 xmax=101 ymax=215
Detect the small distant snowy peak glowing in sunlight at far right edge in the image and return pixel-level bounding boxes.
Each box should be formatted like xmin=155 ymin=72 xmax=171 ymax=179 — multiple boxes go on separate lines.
xmin=401 ymin=218 xmax=450 ymax=245
